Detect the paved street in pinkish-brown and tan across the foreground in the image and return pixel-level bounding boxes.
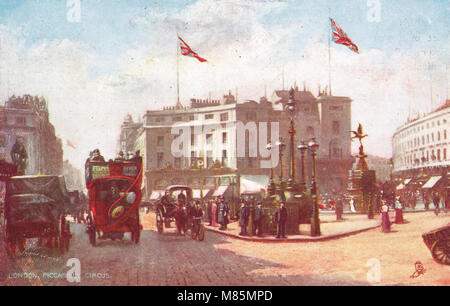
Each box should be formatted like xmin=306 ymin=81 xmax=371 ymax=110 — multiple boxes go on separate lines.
xmin=0 ymin=212 xmax=450 ymax=286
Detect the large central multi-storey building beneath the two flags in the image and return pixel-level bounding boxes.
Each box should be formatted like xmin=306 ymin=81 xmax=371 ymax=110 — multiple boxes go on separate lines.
xmin=120 ymin=88 xmax=353 ymax=201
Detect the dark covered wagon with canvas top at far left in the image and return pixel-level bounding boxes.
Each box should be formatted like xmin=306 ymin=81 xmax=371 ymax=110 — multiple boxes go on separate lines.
xmin=3 ymin=175 xmax=72 ymax=257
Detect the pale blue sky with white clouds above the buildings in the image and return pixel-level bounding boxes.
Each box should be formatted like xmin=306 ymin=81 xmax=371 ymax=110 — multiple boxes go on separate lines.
xmin=0 ymin=0 xmax=450 ymax=168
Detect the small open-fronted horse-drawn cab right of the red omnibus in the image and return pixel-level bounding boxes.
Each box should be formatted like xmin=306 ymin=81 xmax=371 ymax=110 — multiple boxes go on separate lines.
xmin=155 ymin=185 xmax=204 ymax=241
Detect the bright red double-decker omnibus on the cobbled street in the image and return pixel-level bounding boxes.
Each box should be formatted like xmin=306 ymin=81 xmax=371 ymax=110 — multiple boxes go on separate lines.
xmin=85 ymin=157 xmax=142 ymax=246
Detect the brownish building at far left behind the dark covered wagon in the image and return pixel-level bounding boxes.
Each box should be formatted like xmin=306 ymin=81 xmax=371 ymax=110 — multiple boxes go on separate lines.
xmin=0 ymin=95 xmax=63 ymax=175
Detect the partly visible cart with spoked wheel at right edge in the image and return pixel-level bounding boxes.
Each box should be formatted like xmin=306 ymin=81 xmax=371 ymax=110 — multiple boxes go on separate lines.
xmin=422 ymin=224 xmax=450 ymax=265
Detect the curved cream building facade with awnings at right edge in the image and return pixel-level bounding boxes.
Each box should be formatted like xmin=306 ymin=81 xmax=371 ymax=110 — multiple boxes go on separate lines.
xmin=392 ymin=100 xmax=450 ymax=205
